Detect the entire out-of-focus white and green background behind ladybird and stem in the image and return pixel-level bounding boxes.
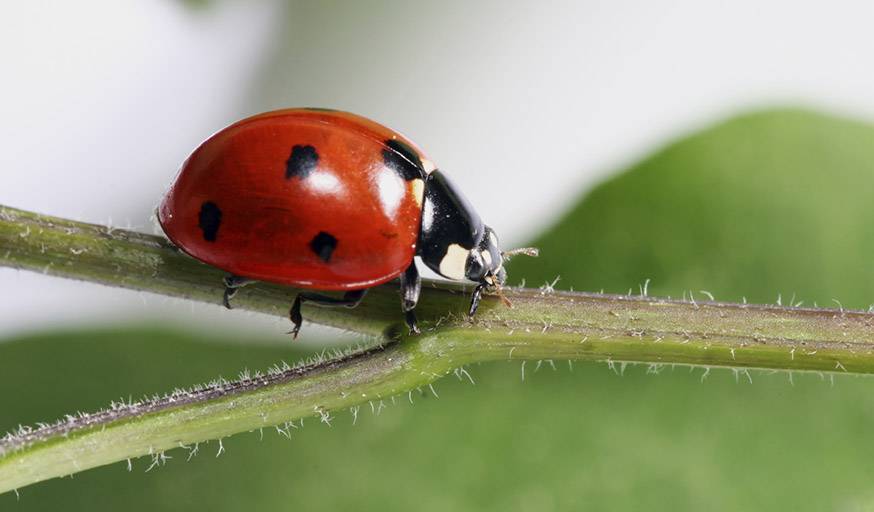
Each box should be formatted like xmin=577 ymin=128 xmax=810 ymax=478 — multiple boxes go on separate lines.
xmin=0 ymin=0 xmax=874 ymax=510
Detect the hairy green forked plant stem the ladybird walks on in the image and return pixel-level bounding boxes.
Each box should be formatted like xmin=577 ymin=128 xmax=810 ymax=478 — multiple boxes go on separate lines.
xmin=0 ymin=203 xmax=874 ymax=492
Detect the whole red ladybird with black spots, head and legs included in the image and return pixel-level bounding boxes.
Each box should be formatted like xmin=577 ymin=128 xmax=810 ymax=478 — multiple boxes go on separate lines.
xmin=158 ymin=109 xmax=534 ymax=337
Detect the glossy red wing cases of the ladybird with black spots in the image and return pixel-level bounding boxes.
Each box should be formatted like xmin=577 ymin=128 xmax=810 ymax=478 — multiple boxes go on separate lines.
xmin=158 ymin=109 xmax=427 ymax=290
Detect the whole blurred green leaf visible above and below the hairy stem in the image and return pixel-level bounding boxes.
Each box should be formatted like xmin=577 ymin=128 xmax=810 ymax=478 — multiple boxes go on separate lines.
xmin=0 ymin=107 xmax=874 ymax=511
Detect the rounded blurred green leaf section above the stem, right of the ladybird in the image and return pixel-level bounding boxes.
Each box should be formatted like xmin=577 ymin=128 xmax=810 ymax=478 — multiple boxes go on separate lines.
xmin=510 ymin=110 xmax=874 ymax=308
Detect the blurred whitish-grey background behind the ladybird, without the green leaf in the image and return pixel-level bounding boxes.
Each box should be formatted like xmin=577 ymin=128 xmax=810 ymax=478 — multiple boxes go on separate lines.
xmin=0 ymin=0 xmax=874 ymax=341
